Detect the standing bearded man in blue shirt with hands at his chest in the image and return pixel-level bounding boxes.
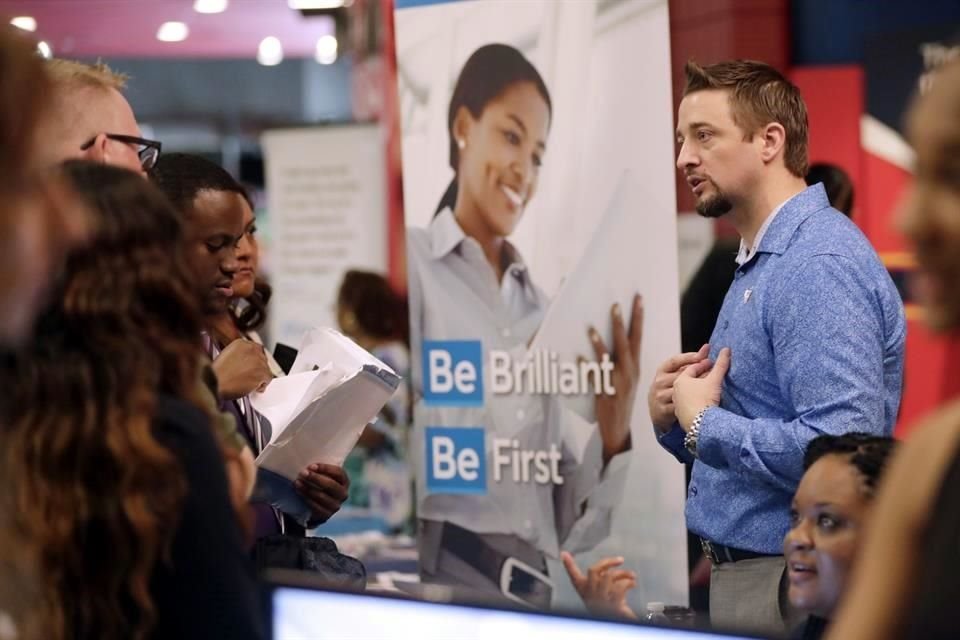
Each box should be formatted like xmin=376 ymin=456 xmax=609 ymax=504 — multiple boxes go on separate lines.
xmin=648 ymin=61 xmax=906 ymax=633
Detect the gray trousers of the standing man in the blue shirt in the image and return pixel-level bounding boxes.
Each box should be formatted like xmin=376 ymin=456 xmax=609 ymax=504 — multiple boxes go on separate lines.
xmin=710 ymin=556 xmax=802 ymax=637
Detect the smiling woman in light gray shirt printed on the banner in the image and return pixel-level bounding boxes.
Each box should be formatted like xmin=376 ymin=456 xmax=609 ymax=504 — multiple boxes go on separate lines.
xmin=408 ymin=44 xmax=643 ymax=607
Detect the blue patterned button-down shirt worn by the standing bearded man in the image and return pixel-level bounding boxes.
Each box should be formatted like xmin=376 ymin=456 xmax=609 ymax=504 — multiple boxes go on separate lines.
xmin=660 ymin=184 xmax=906 ymax=554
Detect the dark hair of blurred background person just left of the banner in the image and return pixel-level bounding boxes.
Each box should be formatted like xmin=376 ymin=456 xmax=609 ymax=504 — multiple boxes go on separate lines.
xmin=337 ymin=270 xmax=410 ymax=342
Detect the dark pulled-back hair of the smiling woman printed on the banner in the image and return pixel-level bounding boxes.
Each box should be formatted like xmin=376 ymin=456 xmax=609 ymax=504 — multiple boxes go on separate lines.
xmin=434 ymin=44 xmax=553 ymax=215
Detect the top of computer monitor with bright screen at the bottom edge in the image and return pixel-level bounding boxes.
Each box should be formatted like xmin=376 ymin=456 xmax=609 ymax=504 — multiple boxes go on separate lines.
xmin=267 ymin=573 xmax=768 ymax=640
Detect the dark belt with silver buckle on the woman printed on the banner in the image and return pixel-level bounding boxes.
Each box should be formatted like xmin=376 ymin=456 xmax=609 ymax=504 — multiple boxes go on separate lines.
xmin=440 ymin=522 xmax=553 ymax=608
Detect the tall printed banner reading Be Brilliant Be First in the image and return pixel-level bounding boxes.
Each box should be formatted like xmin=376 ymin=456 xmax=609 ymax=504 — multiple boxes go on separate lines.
xmin=396 ymin=0 xmax=688 ymax=611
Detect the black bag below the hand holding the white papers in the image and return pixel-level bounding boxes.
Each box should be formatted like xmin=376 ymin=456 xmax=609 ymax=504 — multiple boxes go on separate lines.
xmin=253 ymin=534 xmax=367 ymax=591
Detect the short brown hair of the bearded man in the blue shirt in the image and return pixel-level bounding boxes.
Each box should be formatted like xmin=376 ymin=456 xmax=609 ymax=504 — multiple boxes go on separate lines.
xmin=683 ymin=60 xmax=808 ymax=178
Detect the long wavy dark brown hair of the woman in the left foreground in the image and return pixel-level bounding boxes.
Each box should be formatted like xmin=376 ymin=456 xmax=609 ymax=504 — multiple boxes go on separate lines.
xmin=0 ymin=161 xmax=209 ymax=640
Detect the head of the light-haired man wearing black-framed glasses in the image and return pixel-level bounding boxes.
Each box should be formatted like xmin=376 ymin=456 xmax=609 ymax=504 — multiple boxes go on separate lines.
xmin=39 ymin=59 xmax=160 ymax=174
